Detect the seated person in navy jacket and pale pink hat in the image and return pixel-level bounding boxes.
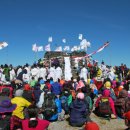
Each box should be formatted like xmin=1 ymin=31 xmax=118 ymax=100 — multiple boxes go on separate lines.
xmin=69 ymin=92 xmax=89 ymax=127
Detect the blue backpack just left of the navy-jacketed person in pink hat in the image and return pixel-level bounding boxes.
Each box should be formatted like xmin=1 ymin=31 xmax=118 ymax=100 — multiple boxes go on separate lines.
xmin=60 ymin=95 xmax=69 ymax=114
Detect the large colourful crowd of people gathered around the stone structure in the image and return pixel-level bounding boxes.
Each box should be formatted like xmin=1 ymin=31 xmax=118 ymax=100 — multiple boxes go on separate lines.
xmin=0 ymin=58 xmax=130 ymax=130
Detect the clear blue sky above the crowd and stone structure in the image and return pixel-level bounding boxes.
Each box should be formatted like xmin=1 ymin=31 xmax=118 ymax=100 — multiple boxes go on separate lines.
xmin=0 ymin=0 xmax=130 ymax=67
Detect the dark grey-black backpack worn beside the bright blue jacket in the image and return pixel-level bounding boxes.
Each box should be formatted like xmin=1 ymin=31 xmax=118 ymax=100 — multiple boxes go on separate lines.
xmin=42 ymin=93 xmax=57 ymax=120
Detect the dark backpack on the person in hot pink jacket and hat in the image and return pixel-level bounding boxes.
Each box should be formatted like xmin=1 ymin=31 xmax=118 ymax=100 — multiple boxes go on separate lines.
xmin=98 ymin=97 xmax=111 ymax=116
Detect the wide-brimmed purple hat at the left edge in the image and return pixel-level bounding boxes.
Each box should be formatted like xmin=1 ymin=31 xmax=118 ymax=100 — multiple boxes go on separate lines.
xmin=0 ymin=99 xmax=16 ymax=113
